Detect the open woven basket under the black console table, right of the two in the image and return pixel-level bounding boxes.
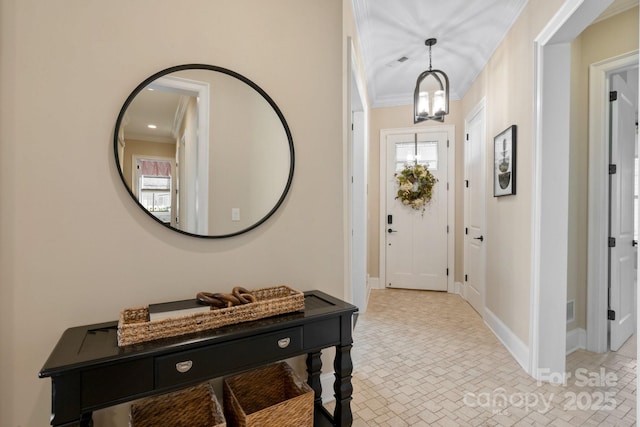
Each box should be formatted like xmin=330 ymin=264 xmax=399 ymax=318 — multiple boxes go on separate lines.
xmin=223 ymin=362 xmax=314 ymax=427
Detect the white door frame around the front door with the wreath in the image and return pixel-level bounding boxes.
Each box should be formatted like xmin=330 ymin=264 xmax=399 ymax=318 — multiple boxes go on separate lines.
xmin=378 ymin=125 xmax=456 ymax=292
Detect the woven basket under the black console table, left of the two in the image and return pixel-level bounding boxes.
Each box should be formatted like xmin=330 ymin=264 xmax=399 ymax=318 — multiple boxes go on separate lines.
xmin=129 ymin=383 xmax=227 ymax=427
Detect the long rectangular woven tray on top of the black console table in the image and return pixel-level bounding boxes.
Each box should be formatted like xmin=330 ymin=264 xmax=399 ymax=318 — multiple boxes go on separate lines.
xmin=118 ymin=286 xmax=304 ymax=347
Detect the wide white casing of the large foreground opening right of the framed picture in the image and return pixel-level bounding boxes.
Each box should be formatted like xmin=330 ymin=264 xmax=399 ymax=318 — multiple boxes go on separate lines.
xmin=529 ymin=0 xmax=613 ymax=382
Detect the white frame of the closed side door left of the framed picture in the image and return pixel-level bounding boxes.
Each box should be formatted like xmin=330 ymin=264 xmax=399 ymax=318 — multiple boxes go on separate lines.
xmin=462 ymin=97 xmax=487 ymax=318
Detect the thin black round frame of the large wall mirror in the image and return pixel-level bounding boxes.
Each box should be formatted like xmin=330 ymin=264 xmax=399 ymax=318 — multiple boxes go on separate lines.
xmin=113 ymin=64 xmax=295 ymax=239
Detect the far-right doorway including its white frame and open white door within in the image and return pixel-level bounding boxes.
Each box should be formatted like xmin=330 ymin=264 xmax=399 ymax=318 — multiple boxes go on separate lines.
xmin=586 ymin=52 xmax=638 ymax=353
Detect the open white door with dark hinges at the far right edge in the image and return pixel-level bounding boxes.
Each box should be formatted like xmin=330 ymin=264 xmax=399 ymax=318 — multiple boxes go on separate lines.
xmin=609 ymin=75 xmax=636 ymax=351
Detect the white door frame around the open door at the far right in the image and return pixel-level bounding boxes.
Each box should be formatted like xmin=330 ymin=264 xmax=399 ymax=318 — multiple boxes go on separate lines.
xmin=587 ymin=51 xmax=639 ymax=353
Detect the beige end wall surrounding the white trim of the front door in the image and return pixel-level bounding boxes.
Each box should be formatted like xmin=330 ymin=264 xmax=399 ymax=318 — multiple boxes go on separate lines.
xmin=367 ymin=101 xmax=464 ymax=282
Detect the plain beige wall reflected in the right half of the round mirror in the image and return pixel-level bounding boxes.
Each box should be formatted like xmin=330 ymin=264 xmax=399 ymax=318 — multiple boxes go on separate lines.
xmin=208 ymin=70 xmax=291 ymax=235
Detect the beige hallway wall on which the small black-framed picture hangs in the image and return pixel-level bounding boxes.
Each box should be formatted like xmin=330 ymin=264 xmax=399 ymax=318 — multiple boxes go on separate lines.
xmin=462 ymin=0 xmax=563 ymax=345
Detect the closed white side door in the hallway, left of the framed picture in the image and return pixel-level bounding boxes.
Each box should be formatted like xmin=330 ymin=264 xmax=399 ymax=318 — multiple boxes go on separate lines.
xmin=463 ymin=110 xmax=485 ymax=316
